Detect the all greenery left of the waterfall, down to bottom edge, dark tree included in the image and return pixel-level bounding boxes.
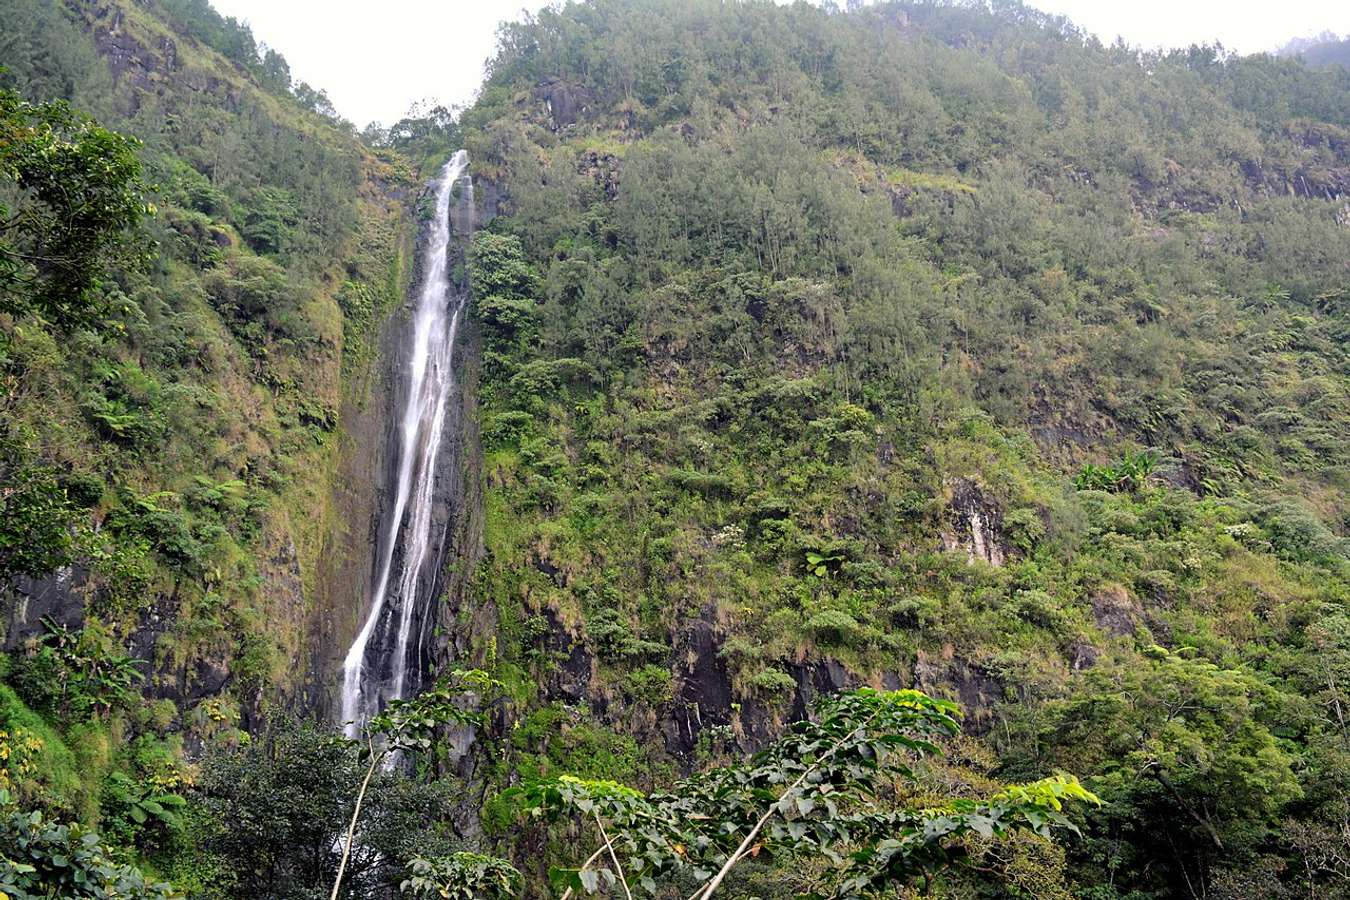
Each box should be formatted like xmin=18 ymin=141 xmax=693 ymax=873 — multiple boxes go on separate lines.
xmin=0 ymin=0 xmax=413 ymax=897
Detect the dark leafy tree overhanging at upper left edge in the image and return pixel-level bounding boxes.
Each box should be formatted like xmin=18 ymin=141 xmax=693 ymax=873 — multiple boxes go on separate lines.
xmin=0 ymin=88 xmax=153 ymax=328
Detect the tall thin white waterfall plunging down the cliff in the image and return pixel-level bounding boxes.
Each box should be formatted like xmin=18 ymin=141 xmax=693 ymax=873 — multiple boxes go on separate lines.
xmin=342 ymin=150 xmax=474 ymax=737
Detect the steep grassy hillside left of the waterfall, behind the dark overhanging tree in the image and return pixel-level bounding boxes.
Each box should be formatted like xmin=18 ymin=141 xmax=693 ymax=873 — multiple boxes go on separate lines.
xmin=0 ymin=0 xmax=417 ymax=842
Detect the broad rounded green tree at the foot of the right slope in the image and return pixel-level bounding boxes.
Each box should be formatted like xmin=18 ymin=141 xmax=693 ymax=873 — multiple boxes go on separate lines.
xmin=1013 ymin=648 xmax=1303 ymax=893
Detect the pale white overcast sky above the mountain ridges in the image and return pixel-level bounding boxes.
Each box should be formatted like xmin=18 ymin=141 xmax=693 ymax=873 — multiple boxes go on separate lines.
xmin=212 ymin=0 xmax=1350 ymax=125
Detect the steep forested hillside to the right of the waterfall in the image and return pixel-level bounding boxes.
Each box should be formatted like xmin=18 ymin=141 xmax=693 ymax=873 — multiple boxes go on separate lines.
xmin=462 ymin=0 xmax=1350 ymax=897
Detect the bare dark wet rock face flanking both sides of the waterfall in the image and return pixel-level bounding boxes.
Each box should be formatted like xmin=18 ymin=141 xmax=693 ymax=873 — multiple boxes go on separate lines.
xmin=308 ymin=168 xmax=495 ymax=718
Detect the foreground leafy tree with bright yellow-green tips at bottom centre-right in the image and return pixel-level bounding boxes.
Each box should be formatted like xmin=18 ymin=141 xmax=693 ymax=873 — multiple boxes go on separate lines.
xmin=520 ymin=690 xmax=1098 ymax=900
